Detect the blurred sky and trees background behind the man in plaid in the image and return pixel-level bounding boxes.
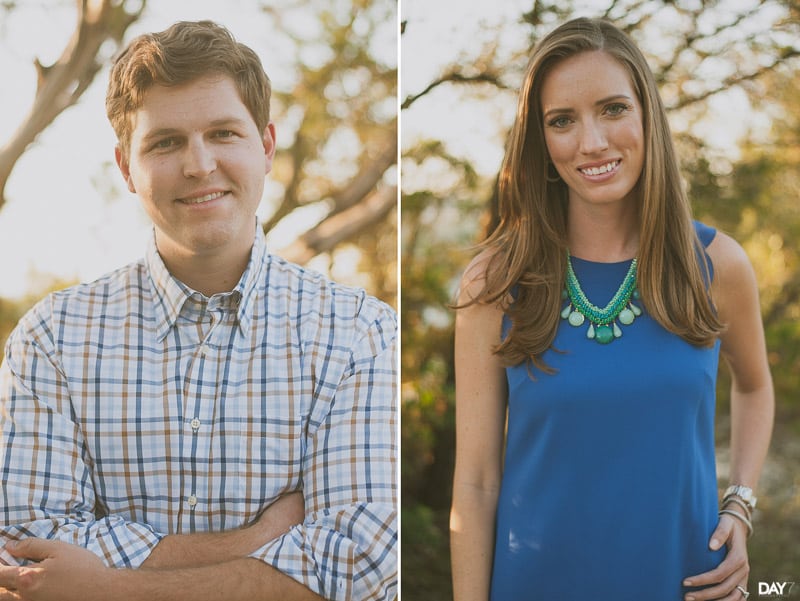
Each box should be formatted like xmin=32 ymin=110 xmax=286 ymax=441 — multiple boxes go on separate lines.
xmin=0 ymin=0 xmax=398 ymax=349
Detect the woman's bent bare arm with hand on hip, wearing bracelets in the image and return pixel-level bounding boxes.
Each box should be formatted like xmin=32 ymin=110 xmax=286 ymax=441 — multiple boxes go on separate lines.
xmin=687 ymin=233 xmax=775 ymax=601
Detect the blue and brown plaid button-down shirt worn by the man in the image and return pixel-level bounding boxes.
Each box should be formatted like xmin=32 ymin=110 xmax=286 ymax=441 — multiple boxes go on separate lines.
xmin=0 ymin=233 xmax=397 ymax=599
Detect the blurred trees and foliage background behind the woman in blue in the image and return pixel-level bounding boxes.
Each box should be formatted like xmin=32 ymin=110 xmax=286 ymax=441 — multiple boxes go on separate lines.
xmin=400 ymin=0 xmax=800 ymax=601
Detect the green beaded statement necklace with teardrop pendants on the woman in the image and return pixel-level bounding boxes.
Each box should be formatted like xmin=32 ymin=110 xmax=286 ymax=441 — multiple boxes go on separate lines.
xmin=561 ymin=251 xmax=642 ymax=344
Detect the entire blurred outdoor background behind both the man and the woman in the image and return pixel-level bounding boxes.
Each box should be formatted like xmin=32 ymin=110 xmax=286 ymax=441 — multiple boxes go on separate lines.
xmin=0 ymin=0 xmax=800 ymax=601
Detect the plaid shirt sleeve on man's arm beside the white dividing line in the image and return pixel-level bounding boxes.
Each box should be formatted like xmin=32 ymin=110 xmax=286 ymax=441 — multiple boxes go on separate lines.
xmin=252 ymin=303 xmax=397 ymax=601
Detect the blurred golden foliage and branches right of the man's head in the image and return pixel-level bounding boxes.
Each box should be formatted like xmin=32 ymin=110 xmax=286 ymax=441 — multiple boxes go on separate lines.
xmin=263 ymin=0 xmax=398 ymax=303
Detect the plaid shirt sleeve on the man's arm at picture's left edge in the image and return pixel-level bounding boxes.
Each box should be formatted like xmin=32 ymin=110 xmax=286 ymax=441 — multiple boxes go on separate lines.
xmin=0 ymin=302 xmax=162 ymax=568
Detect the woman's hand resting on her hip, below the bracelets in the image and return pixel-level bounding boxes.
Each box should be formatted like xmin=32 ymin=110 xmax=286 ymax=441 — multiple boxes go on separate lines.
xmin=683 ymin=514 xmax=750 ymax=601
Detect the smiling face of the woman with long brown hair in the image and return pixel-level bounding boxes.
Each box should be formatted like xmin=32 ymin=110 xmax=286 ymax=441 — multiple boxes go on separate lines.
xmin=541 ymin=51 xmax=644 ymax=212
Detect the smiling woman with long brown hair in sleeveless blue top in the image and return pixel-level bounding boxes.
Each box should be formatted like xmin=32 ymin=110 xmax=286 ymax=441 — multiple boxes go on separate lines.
xmin=451 ymin=19 xmax=774 ymax=601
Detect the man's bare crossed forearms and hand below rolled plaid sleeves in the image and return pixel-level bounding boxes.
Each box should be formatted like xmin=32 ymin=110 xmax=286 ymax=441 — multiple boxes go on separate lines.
xmin=0 ymin=493 xmax=321 ymax=601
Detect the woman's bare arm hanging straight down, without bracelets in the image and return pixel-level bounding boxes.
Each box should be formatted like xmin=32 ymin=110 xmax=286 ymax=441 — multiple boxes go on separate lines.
xmin=450 ymin=256 xmax=507 ymax=601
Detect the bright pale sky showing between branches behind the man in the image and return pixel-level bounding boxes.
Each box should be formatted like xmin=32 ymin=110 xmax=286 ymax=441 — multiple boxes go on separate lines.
xmin=0 ymin=0 xmax=396 ymax=298
